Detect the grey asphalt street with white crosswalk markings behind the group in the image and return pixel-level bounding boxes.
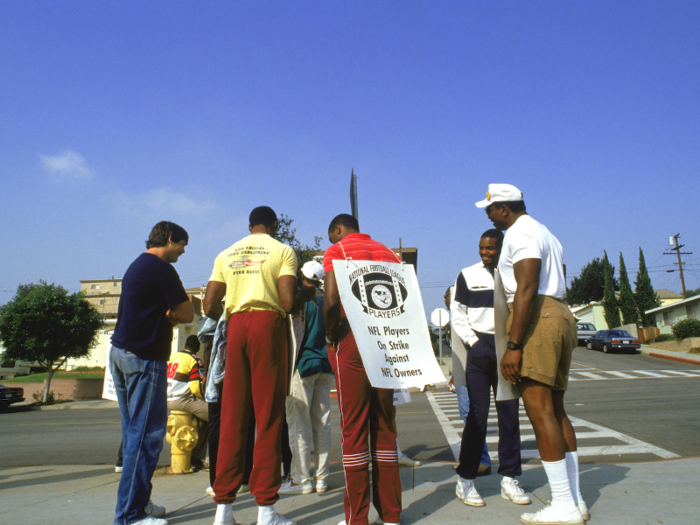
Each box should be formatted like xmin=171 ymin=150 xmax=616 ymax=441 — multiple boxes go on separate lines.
xmin=0 ymin=348 xmax=700 ymax=466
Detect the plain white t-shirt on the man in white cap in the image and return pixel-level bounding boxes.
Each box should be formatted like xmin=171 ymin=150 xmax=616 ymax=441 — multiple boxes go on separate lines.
xmin=498 ymin=215 xmax=566 ymax=304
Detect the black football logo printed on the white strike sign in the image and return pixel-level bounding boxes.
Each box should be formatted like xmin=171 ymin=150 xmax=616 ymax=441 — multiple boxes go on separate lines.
xmin=351 ymin=265 xmax=408 ymax=319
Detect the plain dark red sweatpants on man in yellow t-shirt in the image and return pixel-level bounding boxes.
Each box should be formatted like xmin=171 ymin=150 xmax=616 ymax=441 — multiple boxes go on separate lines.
xmin=214 ymin=311 xmax=288 ymax=505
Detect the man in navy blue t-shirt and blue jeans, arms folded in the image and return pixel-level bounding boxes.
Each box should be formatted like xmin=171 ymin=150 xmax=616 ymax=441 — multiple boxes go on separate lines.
xmin=109 ymin=221 xmax=194 ymax=525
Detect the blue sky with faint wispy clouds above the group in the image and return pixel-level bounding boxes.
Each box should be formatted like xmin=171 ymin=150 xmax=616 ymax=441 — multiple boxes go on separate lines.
xmin=0 ymin=0 xmax=700 ymax=311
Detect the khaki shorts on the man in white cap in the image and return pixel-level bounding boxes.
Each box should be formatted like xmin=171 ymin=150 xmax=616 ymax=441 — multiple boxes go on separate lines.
xmin=506 ymin=295 xmax=578 ymax=390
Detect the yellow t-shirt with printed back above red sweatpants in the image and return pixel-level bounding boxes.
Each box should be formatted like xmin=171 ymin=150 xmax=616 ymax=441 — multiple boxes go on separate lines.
xmin=209 ymin=233 xmax=297 ymax=320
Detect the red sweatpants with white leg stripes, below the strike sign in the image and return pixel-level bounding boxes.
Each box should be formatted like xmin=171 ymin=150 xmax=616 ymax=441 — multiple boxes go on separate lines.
xmin=328 ymin=321 xmax=401 ymax=525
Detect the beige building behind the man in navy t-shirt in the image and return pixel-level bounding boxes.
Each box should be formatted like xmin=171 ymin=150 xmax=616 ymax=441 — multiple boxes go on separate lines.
xmin=66 ymin=278 xmax=203 ymax=370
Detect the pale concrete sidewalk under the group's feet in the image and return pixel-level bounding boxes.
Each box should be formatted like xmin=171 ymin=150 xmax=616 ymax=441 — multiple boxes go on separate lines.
xmin=0 ymin=458 xmax=700 ymax=525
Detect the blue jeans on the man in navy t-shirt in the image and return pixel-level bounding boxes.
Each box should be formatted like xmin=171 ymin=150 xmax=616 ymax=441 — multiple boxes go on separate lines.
xmin=109 ymin=346 xmax=168 ymax=525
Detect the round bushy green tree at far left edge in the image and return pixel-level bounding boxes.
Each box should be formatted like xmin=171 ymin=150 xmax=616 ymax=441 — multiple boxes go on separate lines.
xmin=0 ymin=281 xmax=102 ymax=403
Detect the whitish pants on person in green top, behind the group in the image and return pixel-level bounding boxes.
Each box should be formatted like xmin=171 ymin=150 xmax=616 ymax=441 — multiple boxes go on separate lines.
xmin=287 ymin=370 xmax=333 ymax=484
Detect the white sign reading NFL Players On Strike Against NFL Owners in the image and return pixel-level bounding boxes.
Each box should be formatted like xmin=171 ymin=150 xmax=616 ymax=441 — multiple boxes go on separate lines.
xmin=333 ymin=260 xmax=445 ymax=389
